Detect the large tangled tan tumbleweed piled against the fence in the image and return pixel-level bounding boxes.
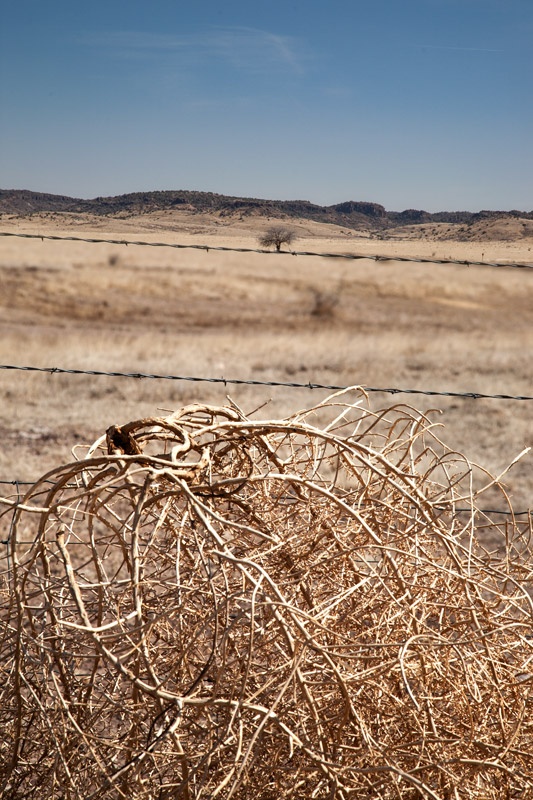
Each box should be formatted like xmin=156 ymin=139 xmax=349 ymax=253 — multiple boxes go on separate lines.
xmin=0 ymin=390 xmax=533 ymax=800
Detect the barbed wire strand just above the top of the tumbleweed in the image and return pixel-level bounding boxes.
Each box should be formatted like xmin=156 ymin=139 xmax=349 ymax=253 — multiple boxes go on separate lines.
xmin=0 ymin=364 xmax=533 ymax=400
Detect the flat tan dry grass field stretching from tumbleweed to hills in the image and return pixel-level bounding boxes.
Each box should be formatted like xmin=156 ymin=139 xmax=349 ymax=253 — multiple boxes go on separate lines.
xmin=0 ymin=212 xmax=533 ymax=510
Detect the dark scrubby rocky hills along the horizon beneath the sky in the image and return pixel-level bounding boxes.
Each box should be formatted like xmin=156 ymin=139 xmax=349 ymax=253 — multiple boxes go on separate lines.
xmin=0 ymin=189 xmax=533 ymax=231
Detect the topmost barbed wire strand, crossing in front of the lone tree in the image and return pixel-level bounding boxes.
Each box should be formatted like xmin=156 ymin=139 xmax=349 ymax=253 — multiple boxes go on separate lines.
xmin=0 ymin=231 xmax=533 ymax=270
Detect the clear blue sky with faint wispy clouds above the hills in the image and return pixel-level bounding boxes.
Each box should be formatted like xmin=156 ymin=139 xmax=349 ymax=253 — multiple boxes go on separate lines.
xmin=0 ymin=0 xmax=533 ymax=211
